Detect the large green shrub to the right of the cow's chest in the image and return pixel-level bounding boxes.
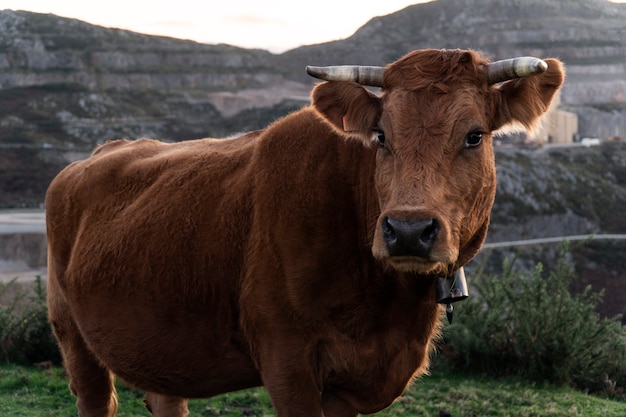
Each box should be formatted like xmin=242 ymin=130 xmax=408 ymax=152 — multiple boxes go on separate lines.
xmin=444 ymin=247 xmax=626 ymax=395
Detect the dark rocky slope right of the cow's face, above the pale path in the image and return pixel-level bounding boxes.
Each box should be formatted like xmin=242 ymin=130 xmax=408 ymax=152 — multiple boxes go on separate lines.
xmin=489 ymin=142 xmax=626 ymax=241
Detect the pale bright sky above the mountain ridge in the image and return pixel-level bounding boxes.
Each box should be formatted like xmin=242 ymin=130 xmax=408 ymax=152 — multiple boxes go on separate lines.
xmin=0 ymin=0 xmax=626 ymax=53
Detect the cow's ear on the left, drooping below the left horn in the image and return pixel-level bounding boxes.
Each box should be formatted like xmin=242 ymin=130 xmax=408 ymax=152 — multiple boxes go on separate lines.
xmin=311 ymin=81 xmax=380 ymax=144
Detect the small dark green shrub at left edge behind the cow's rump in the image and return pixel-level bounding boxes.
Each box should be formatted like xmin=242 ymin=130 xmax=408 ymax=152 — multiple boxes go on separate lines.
xmin=0 ymin=277 xmax=61 ymax=364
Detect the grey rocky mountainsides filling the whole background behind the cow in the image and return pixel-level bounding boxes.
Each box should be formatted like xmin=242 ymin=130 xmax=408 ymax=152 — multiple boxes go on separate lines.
xmin=0 ymin=0 xmax=626 ymax=314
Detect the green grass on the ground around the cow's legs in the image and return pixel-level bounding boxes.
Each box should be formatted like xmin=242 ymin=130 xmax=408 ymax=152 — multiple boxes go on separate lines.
xmin=0 ymin=365 xmax=626 ymax=417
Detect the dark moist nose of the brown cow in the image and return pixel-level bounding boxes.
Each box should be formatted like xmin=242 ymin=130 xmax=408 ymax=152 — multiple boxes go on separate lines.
xmin=382 ymin=217 xmax=440 ymax=259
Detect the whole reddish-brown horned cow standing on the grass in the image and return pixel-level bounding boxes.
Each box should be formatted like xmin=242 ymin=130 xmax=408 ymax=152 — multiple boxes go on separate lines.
xmin=46 ymin=50 xmax=564 ymax=417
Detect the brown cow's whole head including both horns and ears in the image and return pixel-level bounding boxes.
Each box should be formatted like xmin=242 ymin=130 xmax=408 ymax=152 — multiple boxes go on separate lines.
xmin=307 ymin=50 xmax=564 ymax=275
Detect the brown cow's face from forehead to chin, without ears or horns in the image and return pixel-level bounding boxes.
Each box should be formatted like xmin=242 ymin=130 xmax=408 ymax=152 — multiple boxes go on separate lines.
xmin=373 ymin=84 xmax=496 ymax=275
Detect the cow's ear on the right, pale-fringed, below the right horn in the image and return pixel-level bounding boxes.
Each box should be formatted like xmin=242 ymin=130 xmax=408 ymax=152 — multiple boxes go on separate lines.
xmin=491 ymin=59 xmax=565 ymax=130
